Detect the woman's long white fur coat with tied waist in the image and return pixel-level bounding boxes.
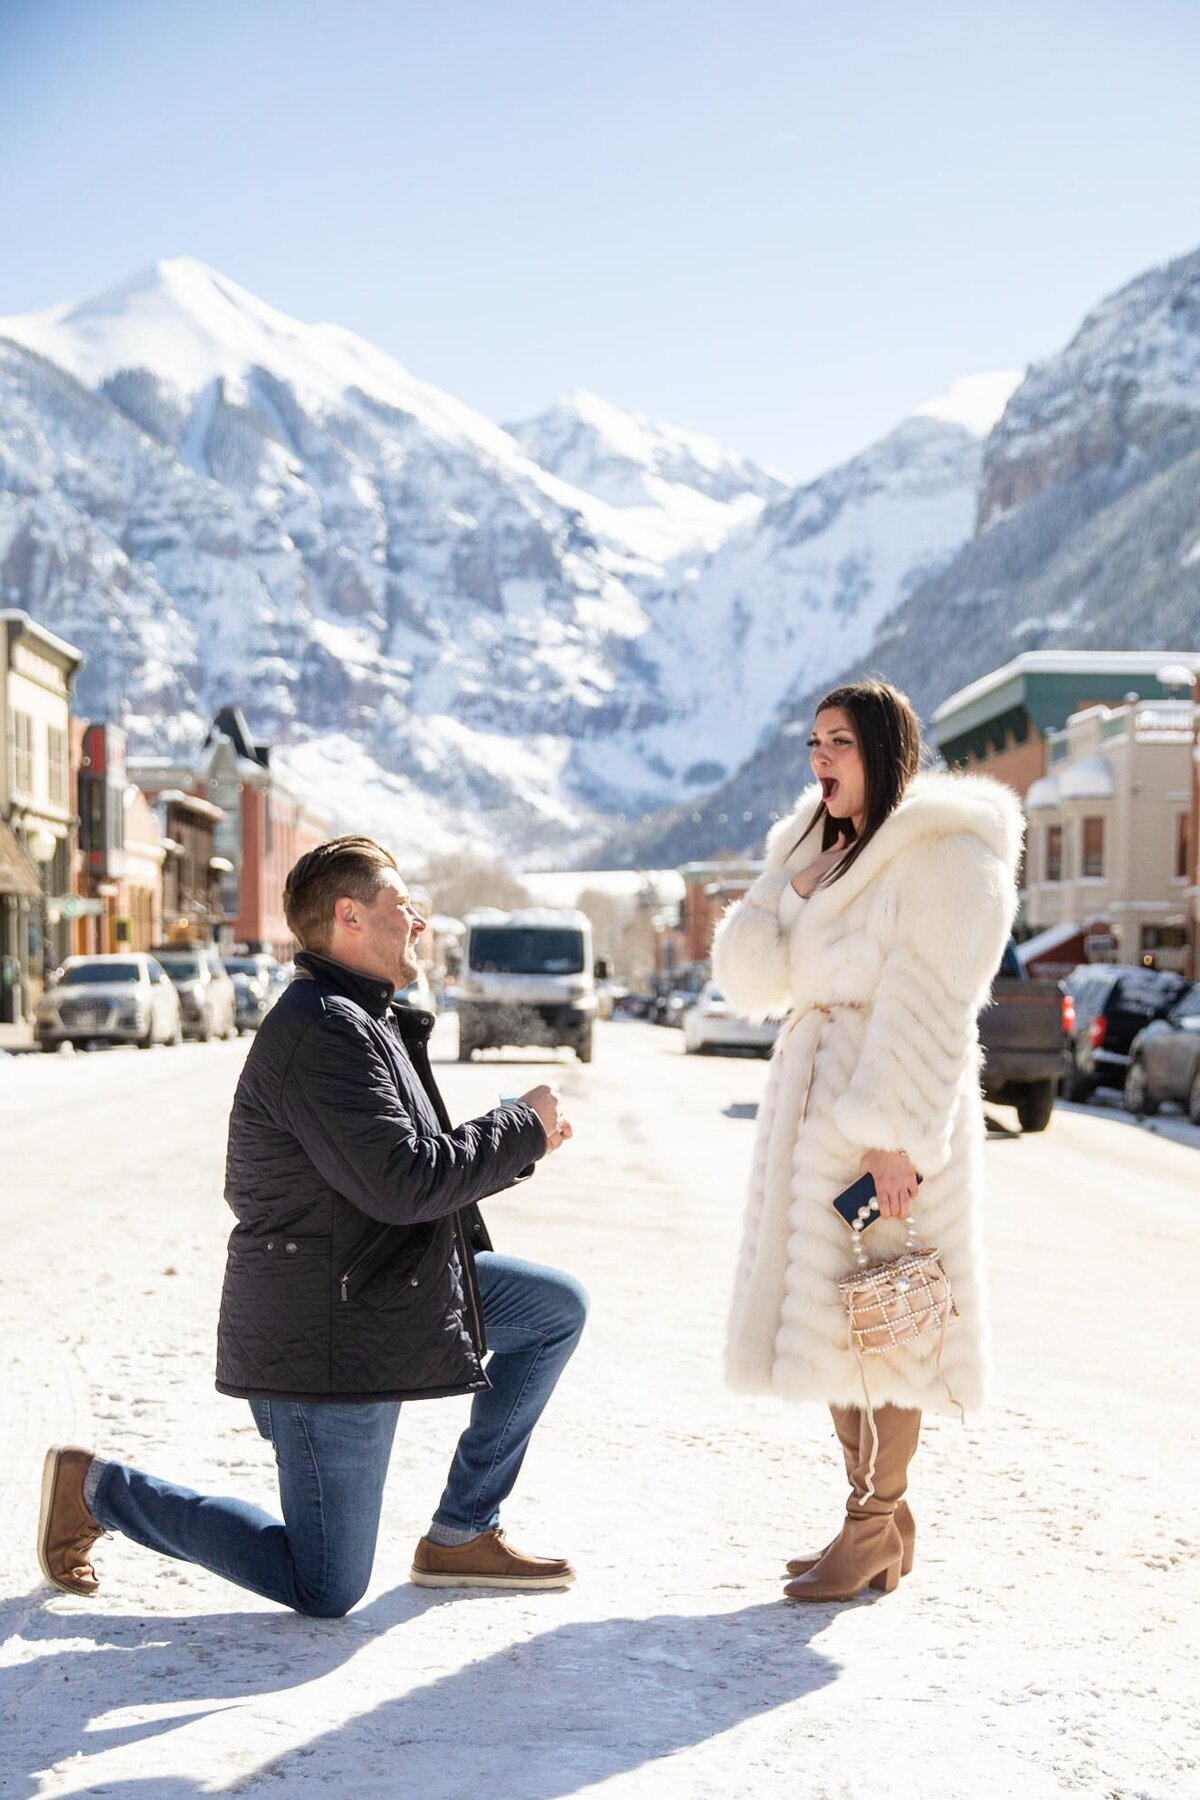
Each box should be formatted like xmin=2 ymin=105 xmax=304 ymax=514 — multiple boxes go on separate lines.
xmin=712 ymin=774 xmax=1022 ymax=1411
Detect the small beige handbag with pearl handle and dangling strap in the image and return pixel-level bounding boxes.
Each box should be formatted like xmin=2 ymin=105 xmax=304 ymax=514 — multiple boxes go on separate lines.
xmin=838 ymin=1199 xmax=963 ymax=1507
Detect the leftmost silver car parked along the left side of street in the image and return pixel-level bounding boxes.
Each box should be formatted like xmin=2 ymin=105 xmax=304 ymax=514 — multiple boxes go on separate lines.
xmin=34 ymin=952 xmax=184 ymax=1049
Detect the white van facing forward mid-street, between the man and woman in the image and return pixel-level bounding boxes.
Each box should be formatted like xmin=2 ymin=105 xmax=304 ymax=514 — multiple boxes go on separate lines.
xmin=459 ymin=907 xmax=596 ymax=1062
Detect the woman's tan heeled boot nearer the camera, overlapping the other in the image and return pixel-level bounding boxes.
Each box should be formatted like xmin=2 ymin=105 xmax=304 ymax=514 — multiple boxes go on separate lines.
xmin=783 ymin=1406 xmax=921 ymax=1600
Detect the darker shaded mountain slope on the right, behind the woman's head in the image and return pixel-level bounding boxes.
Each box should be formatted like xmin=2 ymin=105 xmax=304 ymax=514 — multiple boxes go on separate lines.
xmin=626 ymin=252 xmax=1200 ymax=864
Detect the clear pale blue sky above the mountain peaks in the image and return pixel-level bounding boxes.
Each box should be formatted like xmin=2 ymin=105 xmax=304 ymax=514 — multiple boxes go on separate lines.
xmin=0 ymin=0 xmax=1200 ymax=477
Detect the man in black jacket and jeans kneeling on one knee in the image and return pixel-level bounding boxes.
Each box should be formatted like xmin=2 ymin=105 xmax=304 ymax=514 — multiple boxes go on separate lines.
xmin=38 ymin=837 xmax=587 ymax=1616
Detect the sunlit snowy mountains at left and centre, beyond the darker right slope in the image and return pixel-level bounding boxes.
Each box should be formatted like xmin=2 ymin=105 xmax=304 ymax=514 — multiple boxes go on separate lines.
xmin=0 ymin=257 xmax=1015 ymax=862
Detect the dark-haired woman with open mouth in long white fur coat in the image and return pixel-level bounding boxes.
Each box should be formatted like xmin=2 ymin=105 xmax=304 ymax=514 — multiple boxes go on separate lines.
xmin=712 ymin=682 xmax=1022 ymax=1600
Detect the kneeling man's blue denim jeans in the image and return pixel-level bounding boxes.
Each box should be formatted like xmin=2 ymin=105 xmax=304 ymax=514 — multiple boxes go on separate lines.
xmin=92 ymin=1251 xmax=587 ymax=1618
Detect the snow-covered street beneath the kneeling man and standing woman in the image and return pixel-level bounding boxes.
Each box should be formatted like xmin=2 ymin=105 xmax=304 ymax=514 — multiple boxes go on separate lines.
xmin=0 ymin=1019 xmax=1200 ymax=1800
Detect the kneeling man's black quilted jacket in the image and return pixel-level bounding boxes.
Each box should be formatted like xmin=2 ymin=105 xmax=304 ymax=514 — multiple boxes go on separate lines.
xmin=216 ymin=950 xmax=545 ymax=1400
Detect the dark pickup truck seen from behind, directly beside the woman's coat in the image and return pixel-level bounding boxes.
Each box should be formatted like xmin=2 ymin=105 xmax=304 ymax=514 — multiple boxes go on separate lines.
xmin=979 ymin=938 xmax=1069 ymax=1130
